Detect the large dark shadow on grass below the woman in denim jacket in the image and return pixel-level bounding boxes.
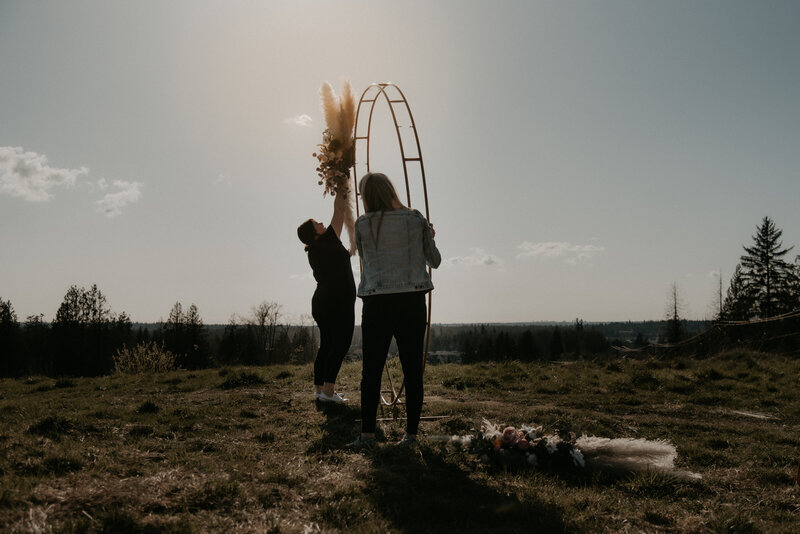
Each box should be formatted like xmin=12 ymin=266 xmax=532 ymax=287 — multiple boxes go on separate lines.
xmin=364 ymin=445 xmax=567 ymax=532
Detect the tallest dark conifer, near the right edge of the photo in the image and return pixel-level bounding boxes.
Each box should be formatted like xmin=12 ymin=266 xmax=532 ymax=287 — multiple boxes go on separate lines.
xmin=729 ymin=217 xmax=800 ymax=319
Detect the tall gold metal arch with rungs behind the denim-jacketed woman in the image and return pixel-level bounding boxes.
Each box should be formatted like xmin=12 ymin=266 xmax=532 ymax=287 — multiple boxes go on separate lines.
xmin=353 ymin=83 xmax=433 ymax=412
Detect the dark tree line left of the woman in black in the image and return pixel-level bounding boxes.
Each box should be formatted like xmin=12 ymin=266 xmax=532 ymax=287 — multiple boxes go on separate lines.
xmin=0 ymin=285 xmax=317 ymax=377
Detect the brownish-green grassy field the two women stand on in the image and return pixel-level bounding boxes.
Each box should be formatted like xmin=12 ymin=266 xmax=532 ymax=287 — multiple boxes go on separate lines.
xmin=0 ymin=352 xmax=800 ymax=533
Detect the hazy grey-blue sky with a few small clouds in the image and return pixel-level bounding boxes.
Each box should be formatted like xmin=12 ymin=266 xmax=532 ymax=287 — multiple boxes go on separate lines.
xmin=0 ymin=0 xmax=800 ymax=324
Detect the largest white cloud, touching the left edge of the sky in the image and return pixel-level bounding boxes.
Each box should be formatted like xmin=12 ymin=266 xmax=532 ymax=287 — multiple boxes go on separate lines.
xmin=0 ymin=146 xmax=89 ymax=202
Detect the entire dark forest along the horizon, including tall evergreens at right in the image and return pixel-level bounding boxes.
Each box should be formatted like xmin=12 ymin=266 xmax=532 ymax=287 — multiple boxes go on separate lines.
xmin=0 ymin=217 xmax=800 ymax=377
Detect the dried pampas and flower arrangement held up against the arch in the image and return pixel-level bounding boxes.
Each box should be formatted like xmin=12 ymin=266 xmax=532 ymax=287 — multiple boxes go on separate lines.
xmin=313 ymin=80 xmax=356 ymax=254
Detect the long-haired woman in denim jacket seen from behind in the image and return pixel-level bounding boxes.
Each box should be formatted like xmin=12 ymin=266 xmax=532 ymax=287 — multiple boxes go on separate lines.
xmin=354 ymin=173 xmax=442 ymax=445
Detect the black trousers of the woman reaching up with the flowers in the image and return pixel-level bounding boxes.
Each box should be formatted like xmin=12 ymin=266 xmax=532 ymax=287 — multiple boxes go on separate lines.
xmin=312 ymin=302 xmax=356 ymax=386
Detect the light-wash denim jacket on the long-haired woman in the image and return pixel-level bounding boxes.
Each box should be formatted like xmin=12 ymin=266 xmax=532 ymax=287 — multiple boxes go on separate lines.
xmin=355 ymin=208 xmax=442 ymax=297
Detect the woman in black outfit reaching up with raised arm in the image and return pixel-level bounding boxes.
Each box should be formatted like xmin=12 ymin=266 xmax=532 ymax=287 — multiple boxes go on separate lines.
xmin=297 ymin=195 xmax=356 ymax=403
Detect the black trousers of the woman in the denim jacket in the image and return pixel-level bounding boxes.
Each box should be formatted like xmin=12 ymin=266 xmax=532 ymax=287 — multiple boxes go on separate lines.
xmin=361 ymin=293 xmax=428 ymax=434
